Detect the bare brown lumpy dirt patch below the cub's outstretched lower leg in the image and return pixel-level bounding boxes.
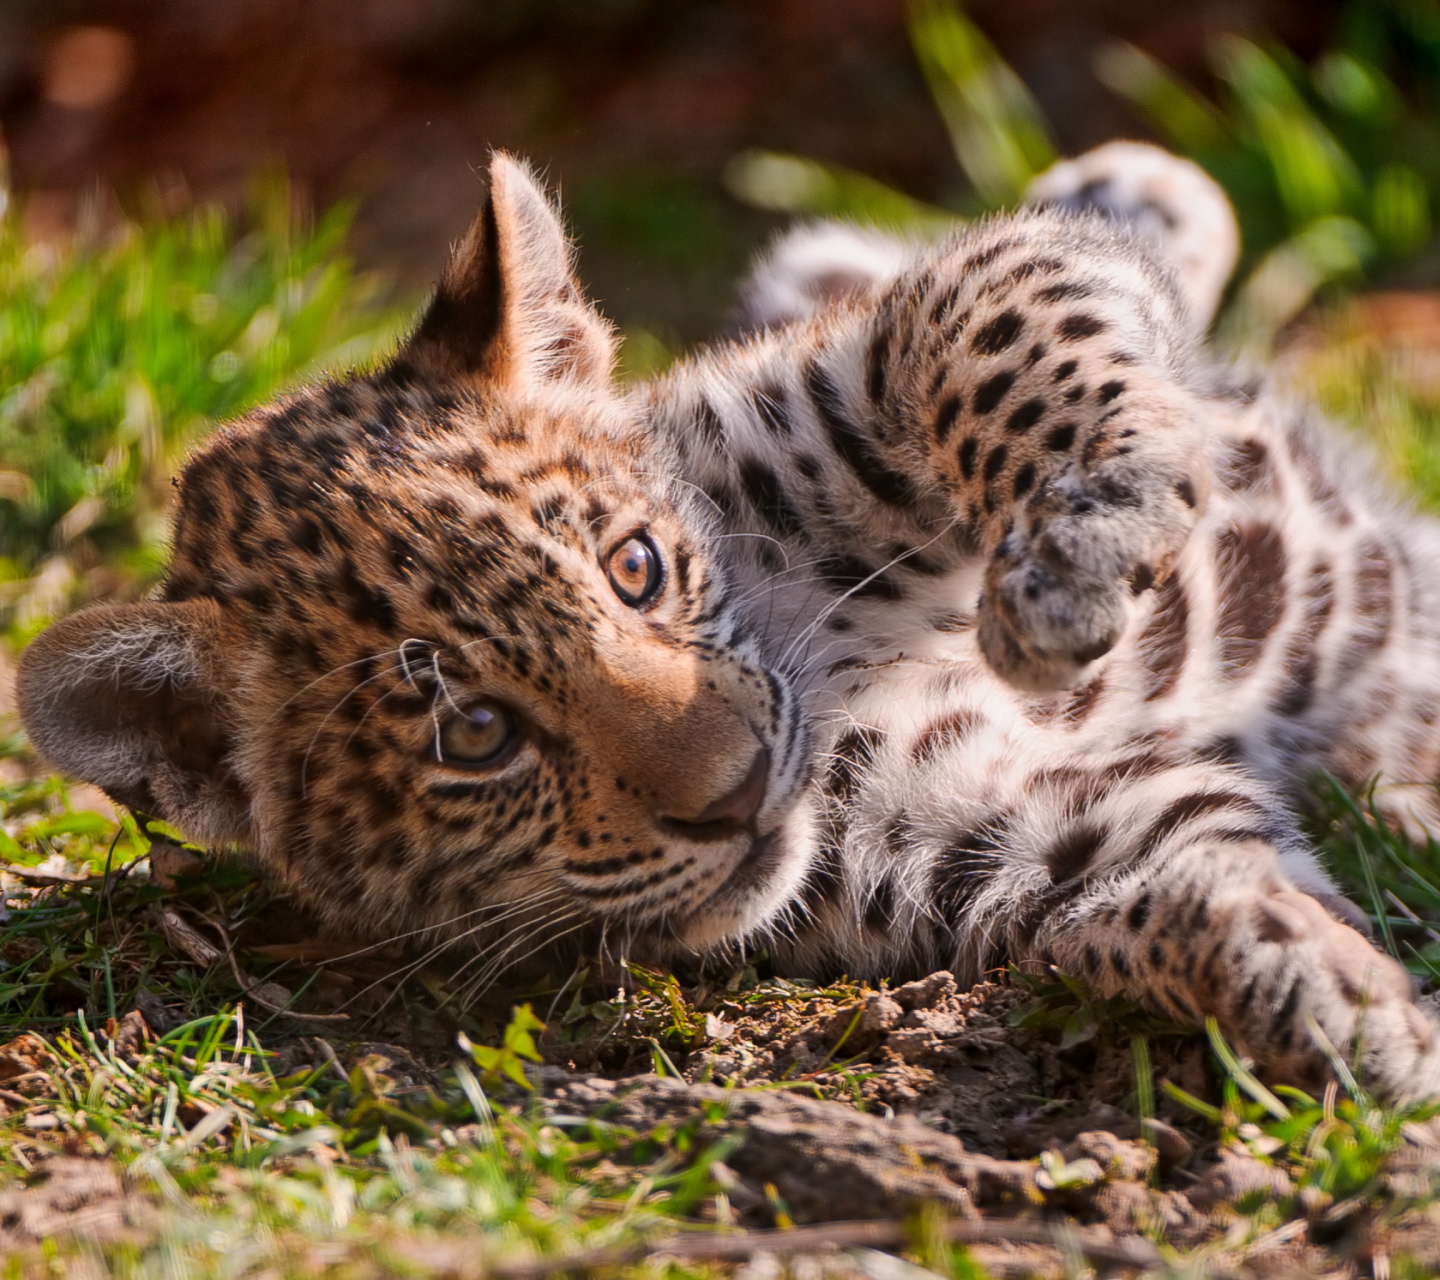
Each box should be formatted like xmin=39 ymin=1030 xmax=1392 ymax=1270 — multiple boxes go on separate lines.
xmin=532 ymin=972 xmax=1440 ymax=1276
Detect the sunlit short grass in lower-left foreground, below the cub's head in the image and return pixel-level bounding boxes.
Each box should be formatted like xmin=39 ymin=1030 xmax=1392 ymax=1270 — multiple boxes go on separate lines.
xmin=0 ymin=1009 xmax=726 ymax=1276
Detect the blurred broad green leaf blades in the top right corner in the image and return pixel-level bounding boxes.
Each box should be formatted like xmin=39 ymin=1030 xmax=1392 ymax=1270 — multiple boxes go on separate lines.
xmin=1097 ymin=3 xmax=1440 ymax=338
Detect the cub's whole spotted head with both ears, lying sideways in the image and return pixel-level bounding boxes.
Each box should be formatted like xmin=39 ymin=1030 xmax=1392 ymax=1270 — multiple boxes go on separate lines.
xmin=19 ymin=157 xmax=808 ymax=956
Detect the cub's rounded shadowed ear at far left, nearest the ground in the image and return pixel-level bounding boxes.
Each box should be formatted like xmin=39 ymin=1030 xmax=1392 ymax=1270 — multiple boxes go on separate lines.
xmin=16 ymin=600 xmax=249 ymax=845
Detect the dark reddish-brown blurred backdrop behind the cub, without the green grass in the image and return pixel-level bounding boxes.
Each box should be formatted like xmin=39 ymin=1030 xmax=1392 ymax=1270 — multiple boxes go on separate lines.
xmin=0 ymin=0 xmax=1365 ymax=340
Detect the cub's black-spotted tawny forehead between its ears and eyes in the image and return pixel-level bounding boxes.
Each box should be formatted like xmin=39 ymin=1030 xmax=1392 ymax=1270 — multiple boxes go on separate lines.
xmin=166 ymin=367 xmax=664 ymax=625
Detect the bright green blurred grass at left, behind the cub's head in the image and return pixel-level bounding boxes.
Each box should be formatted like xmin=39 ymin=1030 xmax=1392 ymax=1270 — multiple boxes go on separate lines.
xmin=0 ymin=171 xmax=392 ymax=629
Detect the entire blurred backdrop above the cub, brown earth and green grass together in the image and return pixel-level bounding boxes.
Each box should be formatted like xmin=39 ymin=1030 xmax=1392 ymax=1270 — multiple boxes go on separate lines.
xmin=0 ymin=0 xmax=1440 ymax=630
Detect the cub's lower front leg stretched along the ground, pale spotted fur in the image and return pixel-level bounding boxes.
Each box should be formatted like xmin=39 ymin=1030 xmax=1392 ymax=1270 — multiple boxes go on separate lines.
xmin=789 ymin=664 xmax=1440 ymax=1097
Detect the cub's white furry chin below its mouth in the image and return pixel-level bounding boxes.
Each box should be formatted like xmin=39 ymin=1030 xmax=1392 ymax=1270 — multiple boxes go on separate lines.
xmin=672 ymin=805 xmax=815 ymax=955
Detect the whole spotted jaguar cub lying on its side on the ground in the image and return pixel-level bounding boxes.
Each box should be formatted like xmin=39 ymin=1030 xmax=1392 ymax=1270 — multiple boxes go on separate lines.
xmin=19 ymin=147 xmax=1440 ymax=1096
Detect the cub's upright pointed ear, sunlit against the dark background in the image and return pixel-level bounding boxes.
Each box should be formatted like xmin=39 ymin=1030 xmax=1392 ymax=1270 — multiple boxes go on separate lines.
xmin=399 ymin=151 xmax=615 ymax=389
